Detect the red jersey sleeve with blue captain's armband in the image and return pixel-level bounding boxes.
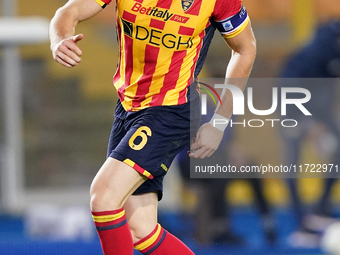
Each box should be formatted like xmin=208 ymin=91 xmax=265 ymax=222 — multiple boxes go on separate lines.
xmin=212 ymin=0 xmax=249 ymax=38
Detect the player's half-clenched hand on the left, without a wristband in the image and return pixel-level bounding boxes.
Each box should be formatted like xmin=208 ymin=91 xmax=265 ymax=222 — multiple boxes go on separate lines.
xmin=51 ymin=34 xmax=84 ymax=67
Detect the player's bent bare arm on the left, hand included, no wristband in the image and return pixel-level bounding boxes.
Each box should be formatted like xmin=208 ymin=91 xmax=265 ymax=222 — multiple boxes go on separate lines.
xmin=49 ymin=0 xmax=102 ymax=67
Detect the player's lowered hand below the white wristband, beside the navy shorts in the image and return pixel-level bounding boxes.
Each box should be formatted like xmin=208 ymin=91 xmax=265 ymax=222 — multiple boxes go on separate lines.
xmin=189 ymin=123 xmax=223 ymax=159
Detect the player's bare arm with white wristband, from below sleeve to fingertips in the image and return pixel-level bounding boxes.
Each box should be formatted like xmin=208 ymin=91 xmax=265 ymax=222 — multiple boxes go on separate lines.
xmin=189 ymin=21 xmax=256 ymax=159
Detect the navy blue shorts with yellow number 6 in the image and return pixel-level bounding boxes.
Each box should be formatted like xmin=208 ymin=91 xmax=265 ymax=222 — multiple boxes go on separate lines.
xmin=107 ymin=98 xmax=200 ymax=200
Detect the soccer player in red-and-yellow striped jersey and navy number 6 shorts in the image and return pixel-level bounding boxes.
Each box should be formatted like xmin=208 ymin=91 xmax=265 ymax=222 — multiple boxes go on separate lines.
xmin=50 ymin=0 xmax=256 ymax=255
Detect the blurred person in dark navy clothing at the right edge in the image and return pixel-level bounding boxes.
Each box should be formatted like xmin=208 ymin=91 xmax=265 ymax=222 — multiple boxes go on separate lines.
xmin=280 ymin=20 xmax=340 ymax=247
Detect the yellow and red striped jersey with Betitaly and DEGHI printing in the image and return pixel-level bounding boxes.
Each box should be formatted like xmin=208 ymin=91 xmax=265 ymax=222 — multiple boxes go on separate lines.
xmin=95 ymin=0 xmax=249 ymax=111
